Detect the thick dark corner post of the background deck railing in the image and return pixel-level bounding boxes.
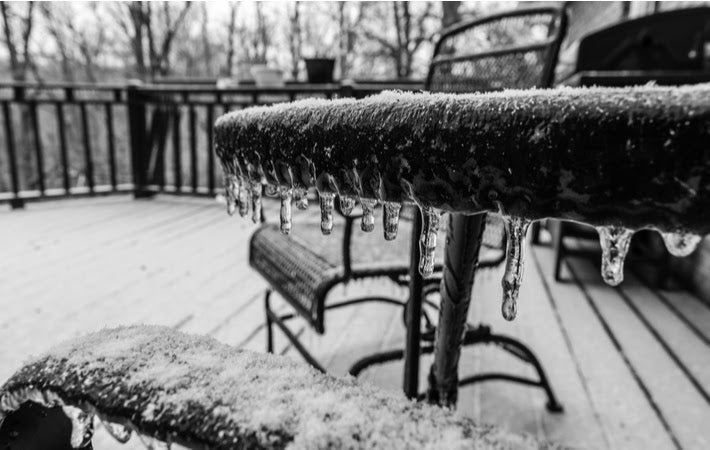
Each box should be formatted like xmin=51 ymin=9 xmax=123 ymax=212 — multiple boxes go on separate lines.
xmin=126 ymin=81 xmax=154 ymax=198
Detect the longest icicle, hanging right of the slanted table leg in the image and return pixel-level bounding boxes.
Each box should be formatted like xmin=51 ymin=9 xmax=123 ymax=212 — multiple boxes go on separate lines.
xmin=501 ymin=216 xmax=530 ymax=320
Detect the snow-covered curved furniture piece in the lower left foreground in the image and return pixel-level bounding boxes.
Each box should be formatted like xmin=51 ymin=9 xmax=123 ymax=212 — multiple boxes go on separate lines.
xmin=0 ymin=326 xmax=547 ymax=449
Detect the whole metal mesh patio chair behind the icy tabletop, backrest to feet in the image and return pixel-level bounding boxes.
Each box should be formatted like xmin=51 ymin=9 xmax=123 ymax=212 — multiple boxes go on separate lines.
xmin=250 ymin=8 xmax=566 ymax=411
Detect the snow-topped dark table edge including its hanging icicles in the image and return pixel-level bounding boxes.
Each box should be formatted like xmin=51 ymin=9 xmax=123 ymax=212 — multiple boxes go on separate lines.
xmin=215 ymin=84 xmax=710 ymax=320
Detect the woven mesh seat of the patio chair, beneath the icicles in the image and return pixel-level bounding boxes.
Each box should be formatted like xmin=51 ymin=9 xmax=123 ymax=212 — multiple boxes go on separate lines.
xmin=249 ymin=209 xmax=504 ymax=333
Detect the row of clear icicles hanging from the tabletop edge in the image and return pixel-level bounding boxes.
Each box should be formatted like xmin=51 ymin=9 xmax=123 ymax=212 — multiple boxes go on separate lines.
xmin=225 ymin=175 xmax=702 ymax=320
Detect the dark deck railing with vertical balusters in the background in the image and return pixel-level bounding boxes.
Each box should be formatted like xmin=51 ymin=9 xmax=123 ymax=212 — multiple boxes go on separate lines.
xmin=0 ymin=82 xmax=421 ymax=207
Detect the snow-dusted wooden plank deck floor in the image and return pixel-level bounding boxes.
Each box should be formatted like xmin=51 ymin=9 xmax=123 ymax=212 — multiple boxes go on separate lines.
xmin=0 ymin=197 xmax=710 ymax=449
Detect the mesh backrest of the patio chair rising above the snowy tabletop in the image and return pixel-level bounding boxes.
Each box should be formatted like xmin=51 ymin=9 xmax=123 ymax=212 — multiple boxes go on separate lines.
xmin=426 ymin=7 xmax=567 ymax=92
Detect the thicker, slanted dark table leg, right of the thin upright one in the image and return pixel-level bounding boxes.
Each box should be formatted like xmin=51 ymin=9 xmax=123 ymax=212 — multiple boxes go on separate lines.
xmin=427 ymin=214 xmax=486 ymax=406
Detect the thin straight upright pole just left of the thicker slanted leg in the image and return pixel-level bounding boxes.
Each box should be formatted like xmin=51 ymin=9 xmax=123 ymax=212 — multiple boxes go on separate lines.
xmin=403 ymin=214 xmax=424 ymax=398
